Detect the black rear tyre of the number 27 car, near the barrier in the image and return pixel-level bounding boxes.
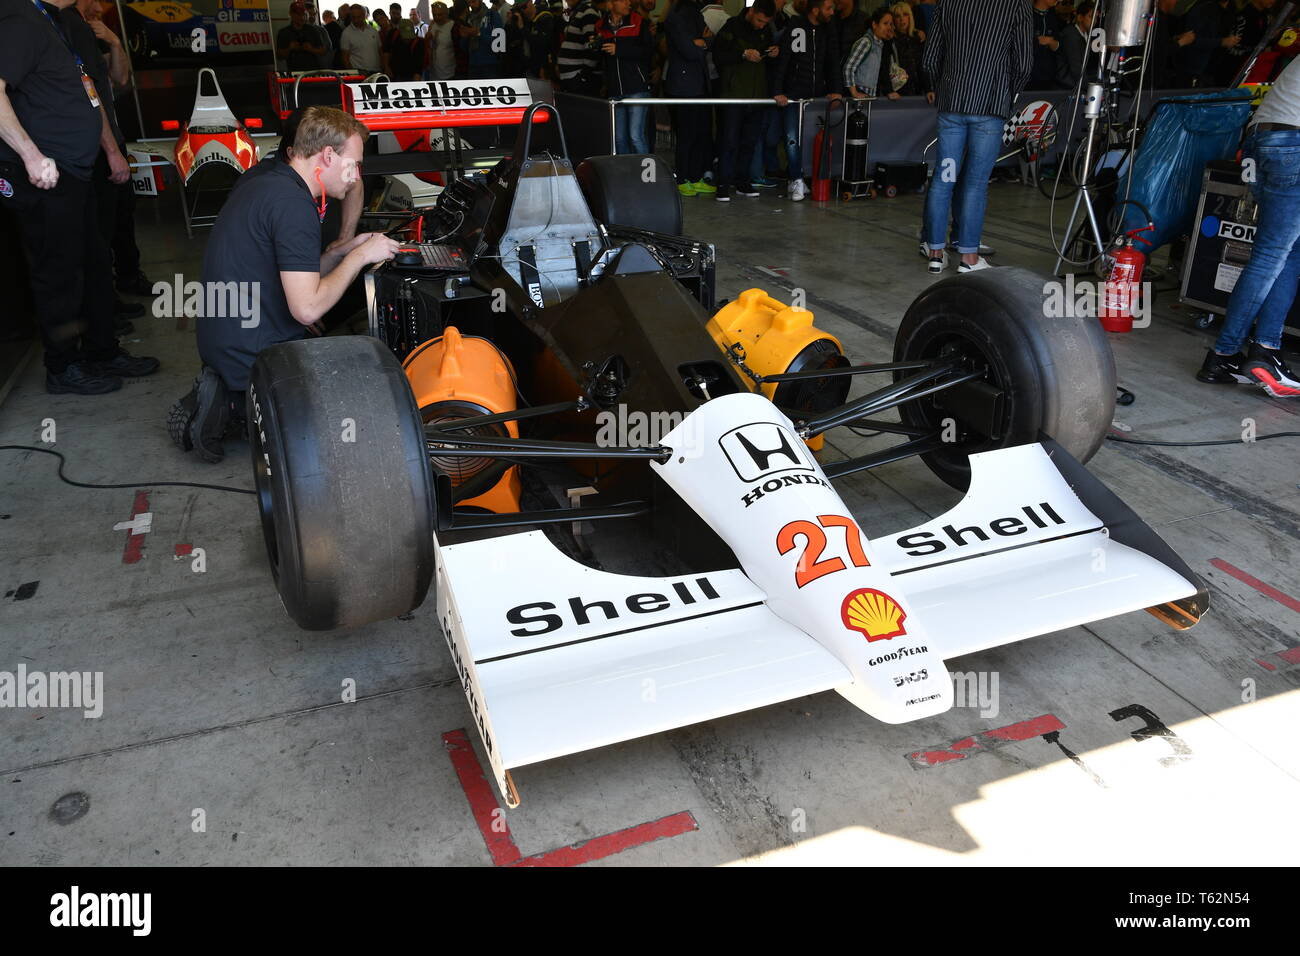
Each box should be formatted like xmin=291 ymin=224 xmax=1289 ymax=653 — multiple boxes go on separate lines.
xmin=577 ymin=156 xmax=681 ymax=235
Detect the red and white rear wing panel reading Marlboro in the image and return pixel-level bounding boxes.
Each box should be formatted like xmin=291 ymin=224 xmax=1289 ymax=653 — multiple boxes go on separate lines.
xmin=343 ymin=78 xmax=549 ymax=131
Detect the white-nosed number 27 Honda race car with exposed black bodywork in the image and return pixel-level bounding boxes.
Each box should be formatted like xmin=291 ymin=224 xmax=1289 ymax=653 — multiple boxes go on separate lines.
xmin=248 ymin=104 xmax=1208 ymax=805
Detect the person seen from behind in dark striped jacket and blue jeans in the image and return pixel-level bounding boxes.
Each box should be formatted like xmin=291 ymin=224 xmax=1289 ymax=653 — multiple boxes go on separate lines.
xmin=922 ymin=0 xmax=1034 ymax=273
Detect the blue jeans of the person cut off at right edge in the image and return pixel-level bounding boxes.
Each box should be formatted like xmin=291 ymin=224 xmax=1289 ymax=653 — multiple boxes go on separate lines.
xmin=1214 ymin=130 xmax=1300 ymax=355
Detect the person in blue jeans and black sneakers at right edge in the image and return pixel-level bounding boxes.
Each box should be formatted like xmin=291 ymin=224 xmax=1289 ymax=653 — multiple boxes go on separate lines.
xmin=1196 ymin=60 xmax=1300 ymax=398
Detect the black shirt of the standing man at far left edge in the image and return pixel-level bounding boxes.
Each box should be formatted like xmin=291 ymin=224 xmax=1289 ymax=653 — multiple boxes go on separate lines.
xmin=0 ymin=0 xmax=104 ymax=179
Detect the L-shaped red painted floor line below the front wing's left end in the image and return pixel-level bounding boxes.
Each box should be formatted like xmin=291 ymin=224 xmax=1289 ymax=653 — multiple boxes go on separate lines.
xmin=442 ymin=730 xmax=699 ymax=866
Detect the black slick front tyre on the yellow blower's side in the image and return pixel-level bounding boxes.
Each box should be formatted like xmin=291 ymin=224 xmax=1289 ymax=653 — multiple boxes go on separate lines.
xmin=894 ymin=268 xmax=1115 ymax=490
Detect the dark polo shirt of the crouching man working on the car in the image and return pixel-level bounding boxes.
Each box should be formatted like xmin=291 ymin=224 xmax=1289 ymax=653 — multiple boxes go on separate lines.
xmin=198 ymin=161 xmax=321 ymax=392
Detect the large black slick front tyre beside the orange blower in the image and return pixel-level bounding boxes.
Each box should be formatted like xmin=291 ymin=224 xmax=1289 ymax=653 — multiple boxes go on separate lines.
xmin=248 ymin=336 xmax=434 ymax=631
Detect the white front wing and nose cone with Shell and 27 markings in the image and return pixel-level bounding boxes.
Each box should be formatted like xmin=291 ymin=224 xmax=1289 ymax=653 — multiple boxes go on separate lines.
xmin=437 ymin=394 xmax=1208 ymax=806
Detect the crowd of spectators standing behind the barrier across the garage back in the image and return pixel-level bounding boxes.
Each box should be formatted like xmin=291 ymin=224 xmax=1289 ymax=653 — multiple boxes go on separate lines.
xmin=277 ymin=0 xmax=1275 ymax=200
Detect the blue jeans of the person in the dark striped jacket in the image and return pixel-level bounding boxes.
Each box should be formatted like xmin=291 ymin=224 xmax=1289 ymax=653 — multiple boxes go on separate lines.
xmin=923 ymin=113 xmax=1006 ymax=254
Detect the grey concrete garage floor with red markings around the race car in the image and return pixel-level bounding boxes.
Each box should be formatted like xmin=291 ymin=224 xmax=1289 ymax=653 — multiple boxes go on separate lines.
xmin=0 ymin=171 xmax=1300 ymax=865
